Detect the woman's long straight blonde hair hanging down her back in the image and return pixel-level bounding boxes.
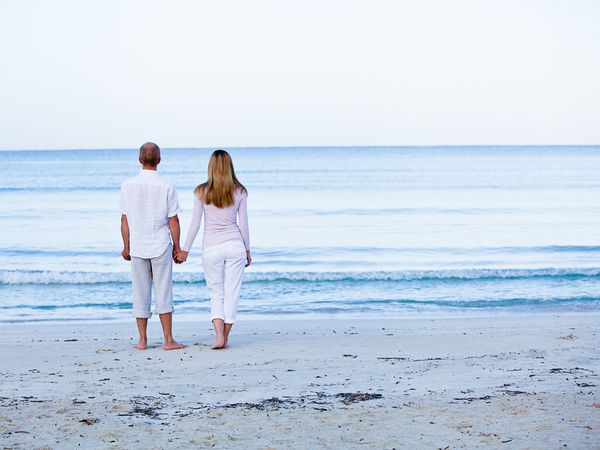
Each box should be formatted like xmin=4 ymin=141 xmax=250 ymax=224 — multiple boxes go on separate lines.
xmin=194 ymin=150 xmax=248 ymax=208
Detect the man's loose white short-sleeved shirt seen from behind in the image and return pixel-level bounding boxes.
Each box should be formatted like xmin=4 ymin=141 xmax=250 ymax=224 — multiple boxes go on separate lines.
xmin=120 ymin=170 xmax=180 ymax=258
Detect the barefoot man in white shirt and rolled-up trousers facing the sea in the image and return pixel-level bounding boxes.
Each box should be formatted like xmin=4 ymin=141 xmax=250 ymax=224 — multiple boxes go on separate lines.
xmin=121 ymin=142 xmax=184 ymax=350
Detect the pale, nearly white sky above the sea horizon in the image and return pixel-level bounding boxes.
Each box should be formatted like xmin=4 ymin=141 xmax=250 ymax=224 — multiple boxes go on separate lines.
xmin=0 ymin=0 xmax=600 ymax=150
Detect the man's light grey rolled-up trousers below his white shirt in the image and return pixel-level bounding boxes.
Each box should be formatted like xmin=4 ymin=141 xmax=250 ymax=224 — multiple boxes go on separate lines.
xmin=131 ymin=244 xmax=173 ymax=319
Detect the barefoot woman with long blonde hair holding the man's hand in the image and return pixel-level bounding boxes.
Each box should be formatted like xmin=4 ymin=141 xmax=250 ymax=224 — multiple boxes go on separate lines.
xmin=175 ymin=150 xmax=252 ymax=349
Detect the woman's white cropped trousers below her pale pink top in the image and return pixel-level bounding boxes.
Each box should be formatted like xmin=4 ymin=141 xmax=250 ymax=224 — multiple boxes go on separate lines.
xmin=202 ymin=241 xmax=246 ymax=323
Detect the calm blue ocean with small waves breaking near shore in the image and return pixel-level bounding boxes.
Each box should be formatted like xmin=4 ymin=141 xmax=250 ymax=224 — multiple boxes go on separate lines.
xmin=0 ymin=146 xmax=600 ymax=322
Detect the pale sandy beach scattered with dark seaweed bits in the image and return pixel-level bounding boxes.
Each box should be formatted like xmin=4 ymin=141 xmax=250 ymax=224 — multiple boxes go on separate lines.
xmin=0 ymin=313 xmax=600 ymax=449
